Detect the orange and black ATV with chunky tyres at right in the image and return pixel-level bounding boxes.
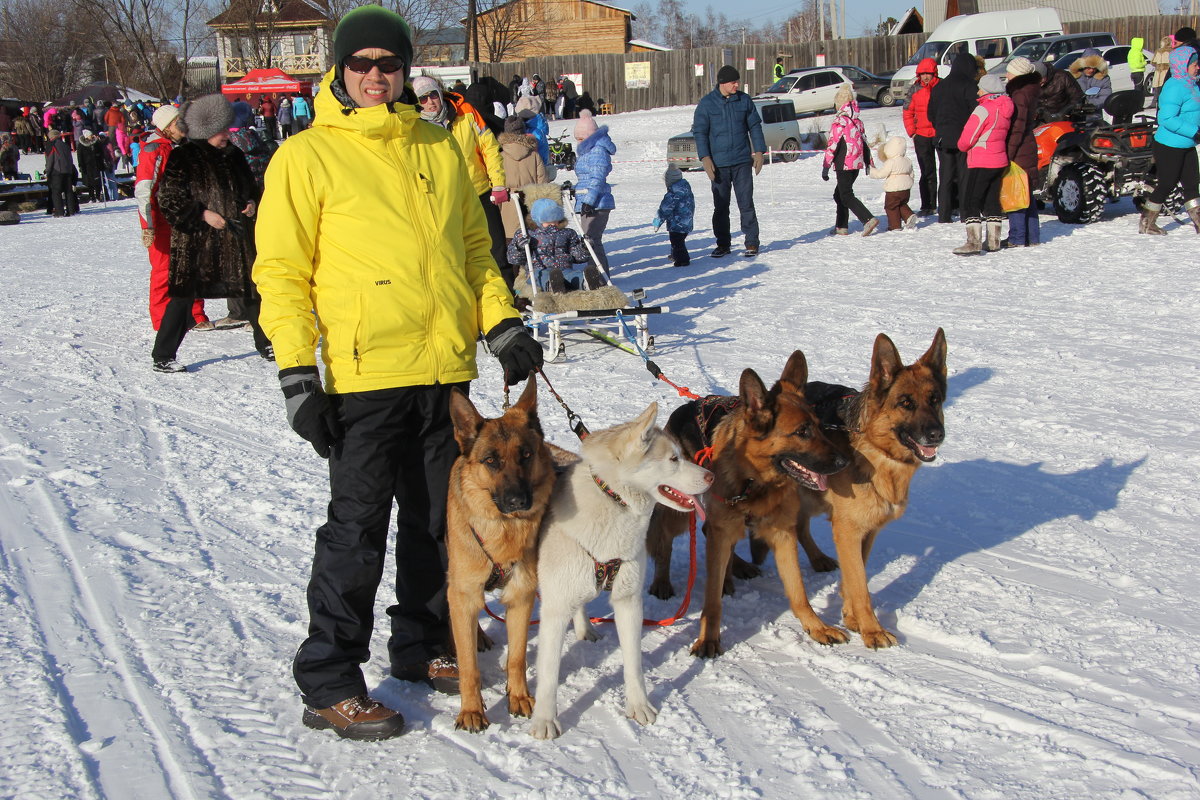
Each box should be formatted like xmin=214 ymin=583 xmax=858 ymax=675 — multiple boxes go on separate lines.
xmin=1034 ymin=90 xmax=1180 ymax=224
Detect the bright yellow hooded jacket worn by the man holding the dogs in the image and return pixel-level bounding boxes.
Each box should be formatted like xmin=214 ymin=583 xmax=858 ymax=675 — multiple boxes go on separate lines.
xmin=253 ymin=70 xmax=520 ymax=393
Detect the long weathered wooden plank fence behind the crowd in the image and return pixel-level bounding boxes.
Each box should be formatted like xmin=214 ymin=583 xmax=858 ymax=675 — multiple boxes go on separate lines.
xmin=472 ymin=16 xmax=1198 ymax=112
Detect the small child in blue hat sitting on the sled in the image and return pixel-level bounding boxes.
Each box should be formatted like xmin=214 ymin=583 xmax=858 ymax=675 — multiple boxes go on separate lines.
xmin=508 ymin=198 xmax=602 ymax=293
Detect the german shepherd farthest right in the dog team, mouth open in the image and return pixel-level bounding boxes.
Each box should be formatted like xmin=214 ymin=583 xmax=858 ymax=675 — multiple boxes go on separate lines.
xmin=796 ymin=329 xmax=946 ymax=649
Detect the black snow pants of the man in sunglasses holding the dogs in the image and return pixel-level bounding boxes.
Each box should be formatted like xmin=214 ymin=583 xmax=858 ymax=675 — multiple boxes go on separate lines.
xmin=293 ymin=383 xmax=469 ymax=708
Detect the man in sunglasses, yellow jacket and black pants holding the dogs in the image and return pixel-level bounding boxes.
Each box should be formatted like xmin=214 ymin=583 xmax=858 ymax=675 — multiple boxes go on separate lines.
xmin=254 ymin=6 xmax=542 ymax=740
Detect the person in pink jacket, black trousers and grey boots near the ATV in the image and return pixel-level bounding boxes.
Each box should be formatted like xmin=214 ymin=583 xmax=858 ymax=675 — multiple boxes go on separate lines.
xmin=954 ymin=74 xmax=1015 ymax=255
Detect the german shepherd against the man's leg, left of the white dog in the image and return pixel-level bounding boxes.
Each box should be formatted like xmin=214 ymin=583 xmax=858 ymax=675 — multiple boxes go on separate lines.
xmin=446 ymin=377 xmax=554 ymax=733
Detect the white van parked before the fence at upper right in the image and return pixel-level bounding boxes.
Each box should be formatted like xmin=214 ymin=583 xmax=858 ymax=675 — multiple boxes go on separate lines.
xmin=892 ymin=8 xmax=1062 ymax=98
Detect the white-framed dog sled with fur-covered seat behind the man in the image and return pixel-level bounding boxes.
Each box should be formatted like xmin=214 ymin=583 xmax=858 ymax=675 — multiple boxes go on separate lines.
xmin=512 ymin=182 xmax=670 ymax=361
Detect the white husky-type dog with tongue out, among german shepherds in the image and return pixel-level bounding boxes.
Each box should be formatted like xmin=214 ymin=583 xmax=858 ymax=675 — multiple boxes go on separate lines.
xmin=529 ymin=403 xmax=713 ymax=739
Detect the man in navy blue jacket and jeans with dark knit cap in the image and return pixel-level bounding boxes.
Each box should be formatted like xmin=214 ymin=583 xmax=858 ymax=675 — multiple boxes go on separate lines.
xmin=691 ymin=65 xmax=767 ymax=258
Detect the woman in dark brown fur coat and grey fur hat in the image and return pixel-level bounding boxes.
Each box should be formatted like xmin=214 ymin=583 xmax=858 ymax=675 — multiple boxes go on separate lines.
xmin=152 ymin=95 xmax=275 ymax=372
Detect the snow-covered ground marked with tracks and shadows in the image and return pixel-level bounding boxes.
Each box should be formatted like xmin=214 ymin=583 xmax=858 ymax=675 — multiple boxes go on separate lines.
xmin=0 ymin=108 xmax=1200 ymax=800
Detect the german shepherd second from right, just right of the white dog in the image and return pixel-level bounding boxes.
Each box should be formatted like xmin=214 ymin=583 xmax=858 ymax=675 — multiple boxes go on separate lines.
xmin=654 ymin=350 xmax=848 ymax=657
